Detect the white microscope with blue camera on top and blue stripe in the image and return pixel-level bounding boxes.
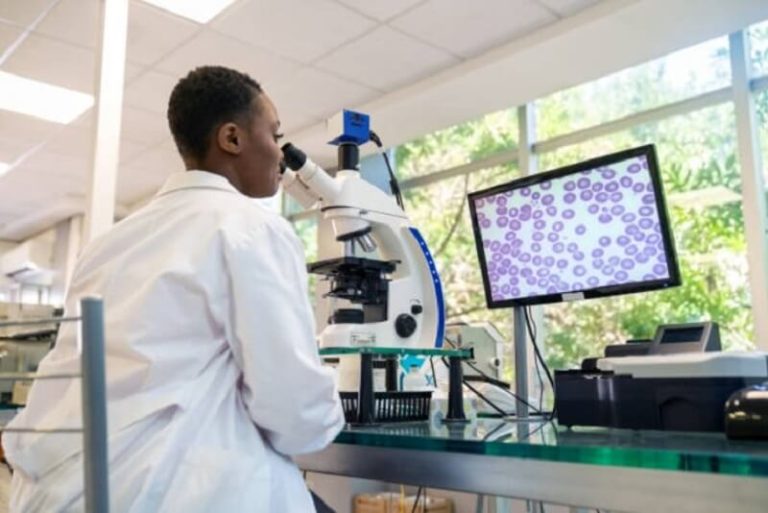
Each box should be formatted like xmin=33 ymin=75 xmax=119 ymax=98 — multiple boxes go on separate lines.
xmin=282 ymin=110 xmax=445 ymax=348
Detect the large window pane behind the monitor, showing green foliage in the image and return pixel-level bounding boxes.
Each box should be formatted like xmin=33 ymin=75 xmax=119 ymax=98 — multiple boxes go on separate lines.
xmin=541 ymin=103 xmax=753 ymax=368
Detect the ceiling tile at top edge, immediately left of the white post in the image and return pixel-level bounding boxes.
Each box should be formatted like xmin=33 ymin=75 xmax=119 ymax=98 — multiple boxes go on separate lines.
xmin=35 ymin=0 xmax=101 ymax=49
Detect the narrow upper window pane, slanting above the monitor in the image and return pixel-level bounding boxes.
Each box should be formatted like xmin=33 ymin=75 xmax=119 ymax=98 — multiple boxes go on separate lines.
xmin=536 ymin=37 xmax=731 ymax=140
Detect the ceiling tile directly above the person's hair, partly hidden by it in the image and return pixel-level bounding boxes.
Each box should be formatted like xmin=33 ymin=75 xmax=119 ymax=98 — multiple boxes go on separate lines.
xmin=156 ymin=30 xmax=298 ymax=84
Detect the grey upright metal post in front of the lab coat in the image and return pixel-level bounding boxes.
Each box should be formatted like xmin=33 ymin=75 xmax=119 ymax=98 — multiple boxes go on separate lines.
xmin=80 ymin=297 xmax=109 ymax=513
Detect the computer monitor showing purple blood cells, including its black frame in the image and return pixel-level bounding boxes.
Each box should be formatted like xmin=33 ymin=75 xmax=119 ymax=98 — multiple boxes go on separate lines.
xmin=469 ymin=145 xmax=680 ymax=308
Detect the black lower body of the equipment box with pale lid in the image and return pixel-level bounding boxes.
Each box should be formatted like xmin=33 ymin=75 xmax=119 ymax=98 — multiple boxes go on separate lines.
xmin=555 ymin=370 xmax=765 ymax=432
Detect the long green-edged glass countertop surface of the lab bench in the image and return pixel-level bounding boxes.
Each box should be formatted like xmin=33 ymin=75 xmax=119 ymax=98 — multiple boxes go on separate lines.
xmin=336 ymin=418 xmax=768 ymax=478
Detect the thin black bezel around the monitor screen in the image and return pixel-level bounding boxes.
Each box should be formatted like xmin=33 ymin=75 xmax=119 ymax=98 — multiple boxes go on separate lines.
xmin=467 ymin=144 xmax=681 ymax=309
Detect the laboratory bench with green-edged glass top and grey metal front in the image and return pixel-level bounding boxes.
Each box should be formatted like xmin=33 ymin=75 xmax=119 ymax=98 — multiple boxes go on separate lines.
xmin=297 ymin=418 xmax=768 ymax=513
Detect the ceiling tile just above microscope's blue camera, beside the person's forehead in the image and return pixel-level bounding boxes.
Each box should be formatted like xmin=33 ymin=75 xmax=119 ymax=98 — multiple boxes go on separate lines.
xmin=267 ymin=67 xmax=380 ymax=119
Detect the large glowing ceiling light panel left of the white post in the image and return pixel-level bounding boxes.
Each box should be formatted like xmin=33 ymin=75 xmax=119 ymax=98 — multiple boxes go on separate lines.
xmin=0 ymin=71 xmax=93 ymax=124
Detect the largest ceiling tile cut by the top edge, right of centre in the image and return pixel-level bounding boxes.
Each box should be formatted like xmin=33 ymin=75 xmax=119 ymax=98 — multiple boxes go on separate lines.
xmin=390 ymin=0 xmax=557 ymax=58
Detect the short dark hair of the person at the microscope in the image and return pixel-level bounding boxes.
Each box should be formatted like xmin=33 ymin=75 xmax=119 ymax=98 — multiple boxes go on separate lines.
xmin=168 ymin=66 xmax=262 ymax=159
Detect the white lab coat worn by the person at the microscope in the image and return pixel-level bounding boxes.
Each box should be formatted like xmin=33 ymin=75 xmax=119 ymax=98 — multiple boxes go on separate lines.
xmin=3 ymin=171 xmax=343 ymax=513
